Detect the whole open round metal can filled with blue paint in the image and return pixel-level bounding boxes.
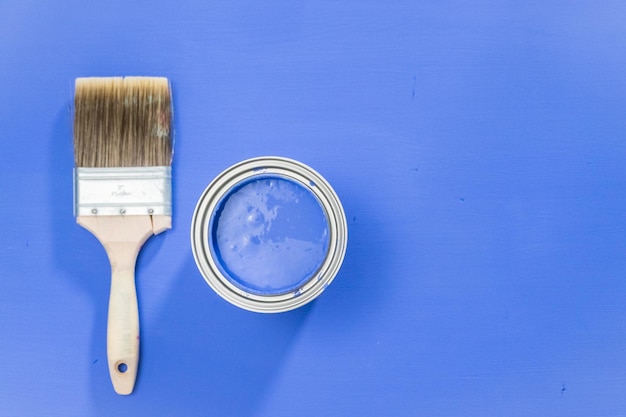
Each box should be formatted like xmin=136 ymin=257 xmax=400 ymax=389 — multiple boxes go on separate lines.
xmin=191 ymin=156 xmax=348 ymax=313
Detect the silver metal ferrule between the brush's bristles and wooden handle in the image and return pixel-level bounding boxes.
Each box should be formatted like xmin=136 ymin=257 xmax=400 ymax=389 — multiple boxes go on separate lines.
xmin=74 ymin=166 xmax=172 ymax=216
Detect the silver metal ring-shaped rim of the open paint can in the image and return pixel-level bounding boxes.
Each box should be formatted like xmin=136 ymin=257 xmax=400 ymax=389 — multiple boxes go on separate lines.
xmin=191 ymin=156 xmax=348 ymax=313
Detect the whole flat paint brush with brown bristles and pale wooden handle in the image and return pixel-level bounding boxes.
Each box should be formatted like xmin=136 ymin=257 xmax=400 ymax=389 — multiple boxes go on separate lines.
xmin=74 ymin=77 xmax=172 ymax=395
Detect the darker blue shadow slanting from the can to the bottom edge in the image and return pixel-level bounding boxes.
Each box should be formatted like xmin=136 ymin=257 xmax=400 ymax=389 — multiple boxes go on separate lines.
xmin=132 ymin=256 xmax=312 ymax=416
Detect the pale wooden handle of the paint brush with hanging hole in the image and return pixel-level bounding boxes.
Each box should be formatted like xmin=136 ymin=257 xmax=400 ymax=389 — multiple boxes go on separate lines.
xmin=77 ymin=215 xmax=171 ymax=395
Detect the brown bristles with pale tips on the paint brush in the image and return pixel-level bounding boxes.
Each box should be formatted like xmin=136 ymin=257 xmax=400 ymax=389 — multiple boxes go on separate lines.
xmin=74 ymin=77 xmax=172 ymax=167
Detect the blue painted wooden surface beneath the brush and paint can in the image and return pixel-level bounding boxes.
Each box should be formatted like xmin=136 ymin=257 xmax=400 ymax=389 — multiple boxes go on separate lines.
xmin=0 ymin=0 xmax=626 ymax=417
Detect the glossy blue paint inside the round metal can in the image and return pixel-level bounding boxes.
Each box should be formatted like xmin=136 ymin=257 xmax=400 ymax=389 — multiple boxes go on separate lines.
xmin=209 ymin=175 xmax=329 ymax=295
